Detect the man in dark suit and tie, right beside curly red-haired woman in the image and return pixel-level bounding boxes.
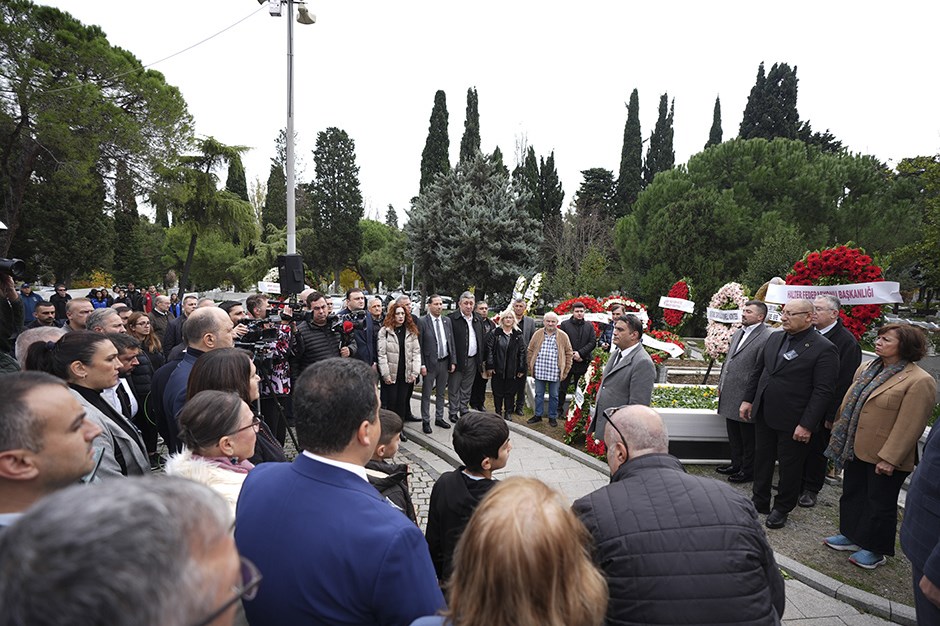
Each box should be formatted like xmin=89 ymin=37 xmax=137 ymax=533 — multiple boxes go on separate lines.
xmin=418 ymin=294 xmax=457 ymax=434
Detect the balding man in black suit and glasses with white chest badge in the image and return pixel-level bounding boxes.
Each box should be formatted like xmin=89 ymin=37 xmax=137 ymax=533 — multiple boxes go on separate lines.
xmin=741 ymin=300 xmax=839 ymax=528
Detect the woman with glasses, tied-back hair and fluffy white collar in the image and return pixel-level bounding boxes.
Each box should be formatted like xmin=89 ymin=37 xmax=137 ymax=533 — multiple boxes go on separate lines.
xmin=166 ymin=391 xmax=261 ymax=514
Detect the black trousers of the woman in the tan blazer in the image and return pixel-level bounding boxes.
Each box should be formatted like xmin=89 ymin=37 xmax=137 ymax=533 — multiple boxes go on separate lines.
xmin=839 ymin=459 xmax=910 ymax=556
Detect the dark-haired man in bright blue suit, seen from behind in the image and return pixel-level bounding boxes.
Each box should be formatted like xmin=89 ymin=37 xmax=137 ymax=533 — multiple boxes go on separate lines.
xmin=235 ymin=358 xmax=445 ymax=626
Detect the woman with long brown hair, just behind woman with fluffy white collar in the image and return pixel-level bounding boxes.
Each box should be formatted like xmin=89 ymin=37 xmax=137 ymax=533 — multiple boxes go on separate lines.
xmin=184 ymin=348 xmax=287 ymax=465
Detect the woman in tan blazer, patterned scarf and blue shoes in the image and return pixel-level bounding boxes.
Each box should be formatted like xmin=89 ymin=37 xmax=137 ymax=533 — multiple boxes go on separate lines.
xmin=825 ymin=324 xmax=937 ymax=569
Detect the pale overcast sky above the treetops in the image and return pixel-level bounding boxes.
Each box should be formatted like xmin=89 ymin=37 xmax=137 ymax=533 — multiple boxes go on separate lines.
xmin=47 ymin=0 xmax=940 ymax=221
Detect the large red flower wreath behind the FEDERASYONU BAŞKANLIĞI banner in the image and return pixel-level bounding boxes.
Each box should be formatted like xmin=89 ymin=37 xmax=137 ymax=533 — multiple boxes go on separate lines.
xmin=786 ymin=246 xmax=884 ymax=339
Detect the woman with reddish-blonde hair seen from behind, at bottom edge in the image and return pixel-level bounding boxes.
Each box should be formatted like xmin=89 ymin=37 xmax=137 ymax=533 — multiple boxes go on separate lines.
xmin=412 ymin=478 xmax=607 ymax=626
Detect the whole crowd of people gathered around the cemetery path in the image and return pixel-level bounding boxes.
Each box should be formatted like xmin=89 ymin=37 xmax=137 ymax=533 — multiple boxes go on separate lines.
xmin=0 ymin=276 xmax=940 ymax=626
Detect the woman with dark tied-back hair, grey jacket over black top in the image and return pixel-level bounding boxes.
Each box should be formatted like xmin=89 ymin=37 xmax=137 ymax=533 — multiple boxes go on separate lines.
xmin=26 ymin=330 xmax=150 ymax=478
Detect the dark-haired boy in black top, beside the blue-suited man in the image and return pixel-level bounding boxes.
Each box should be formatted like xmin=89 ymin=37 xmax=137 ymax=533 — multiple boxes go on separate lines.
xmin=425 ymin=411 xmax=512 ymax=582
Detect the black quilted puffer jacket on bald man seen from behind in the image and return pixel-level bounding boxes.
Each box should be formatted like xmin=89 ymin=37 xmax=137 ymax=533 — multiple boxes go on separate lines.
xmin=573 ymin=454 xmax=784 ymax=626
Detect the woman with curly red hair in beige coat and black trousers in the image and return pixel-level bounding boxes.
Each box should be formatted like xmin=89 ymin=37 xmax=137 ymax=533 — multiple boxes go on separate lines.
xmin=378 ymin=302 xmax=421 ymax=420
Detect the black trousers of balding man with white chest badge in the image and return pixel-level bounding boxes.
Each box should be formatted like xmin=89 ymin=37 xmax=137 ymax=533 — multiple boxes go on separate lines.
xmin=752 ymin=419 xmax=809 ymax=513
